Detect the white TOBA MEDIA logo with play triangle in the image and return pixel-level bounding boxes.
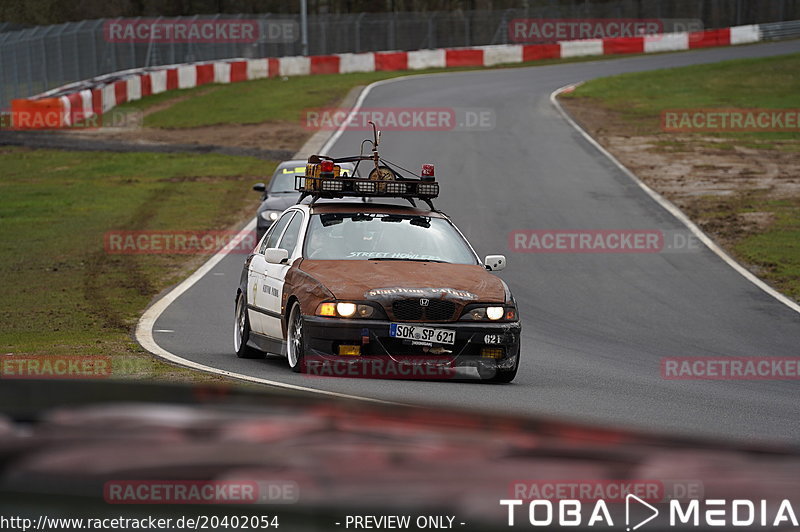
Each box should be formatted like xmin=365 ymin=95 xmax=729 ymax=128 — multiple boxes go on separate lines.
xmin=500 ymin=493 xmax=798 ymax=531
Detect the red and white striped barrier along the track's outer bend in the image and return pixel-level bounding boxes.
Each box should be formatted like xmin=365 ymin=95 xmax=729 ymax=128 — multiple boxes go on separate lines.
xmin=11 ymin=25 xmax=761 ymax=129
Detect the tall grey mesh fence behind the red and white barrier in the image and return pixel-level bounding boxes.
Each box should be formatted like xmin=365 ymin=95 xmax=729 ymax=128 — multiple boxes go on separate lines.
xmin=0 ymin=0 xmax=800 ymax=109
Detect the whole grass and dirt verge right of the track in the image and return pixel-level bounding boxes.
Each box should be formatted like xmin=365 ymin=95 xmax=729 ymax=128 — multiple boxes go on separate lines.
xmin=563 ymin=54 xmax=800 ymax=300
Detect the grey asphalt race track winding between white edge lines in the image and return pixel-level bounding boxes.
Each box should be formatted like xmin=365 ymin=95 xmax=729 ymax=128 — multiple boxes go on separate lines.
xmin=153 ymin=41 xmax=800 ymax=443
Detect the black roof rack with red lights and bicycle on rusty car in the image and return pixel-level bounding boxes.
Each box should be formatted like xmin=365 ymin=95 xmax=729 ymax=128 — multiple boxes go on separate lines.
xmin=295 ymin=121 xmax=439 ymax=211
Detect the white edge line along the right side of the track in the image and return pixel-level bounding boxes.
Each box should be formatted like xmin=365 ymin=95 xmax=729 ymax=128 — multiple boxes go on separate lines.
xmin=550 ymin=81 xmax=800 ymax=313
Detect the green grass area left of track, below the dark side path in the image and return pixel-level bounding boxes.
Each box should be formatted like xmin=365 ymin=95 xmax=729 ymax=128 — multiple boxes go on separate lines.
xmin=0 ymin=148 xmax=275 ymax=377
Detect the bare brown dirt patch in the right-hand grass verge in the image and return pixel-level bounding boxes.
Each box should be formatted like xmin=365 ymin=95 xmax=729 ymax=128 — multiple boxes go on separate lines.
xmin=561 ymin=98 xmax=800 ymax=246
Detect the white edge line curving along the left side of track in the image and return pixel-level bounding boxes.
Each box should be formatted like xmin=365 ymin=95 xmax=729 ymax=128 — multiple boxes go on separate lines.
xmin=134 ymin=74 xmax=435 ymax=406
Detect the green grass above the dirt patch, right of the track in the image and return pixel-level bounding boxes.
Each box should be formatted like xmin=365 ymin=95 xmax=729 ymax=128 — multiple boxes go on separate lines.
xmin=564 ymin=54 xmax=800 ymax=144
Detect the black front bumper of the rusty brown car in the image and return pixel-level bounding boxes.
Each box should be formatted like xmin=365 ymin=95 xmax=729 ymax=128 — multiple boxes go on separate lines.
xmin=303 ymin=316 xmax=522 ymax=369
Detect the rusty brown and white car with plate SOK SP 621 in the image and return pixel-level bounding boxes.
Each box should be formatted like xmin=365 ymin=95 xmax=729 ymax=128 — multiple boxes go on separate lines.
xmin=234 ymin=202 xmax=521 ymax=382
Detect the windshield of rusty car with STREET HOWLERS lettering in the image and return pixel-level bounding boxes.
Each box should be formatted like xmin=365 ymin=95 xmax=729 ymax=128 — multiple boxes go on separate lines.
xmin=304 ymin=213 xmax=477 ymax=264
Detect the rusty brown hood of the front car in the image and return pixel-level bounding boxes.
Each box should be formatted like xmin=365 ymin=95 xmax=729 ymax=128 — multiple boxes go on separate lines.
xmin=300 ymin=259 xmax=505 ymax=303
